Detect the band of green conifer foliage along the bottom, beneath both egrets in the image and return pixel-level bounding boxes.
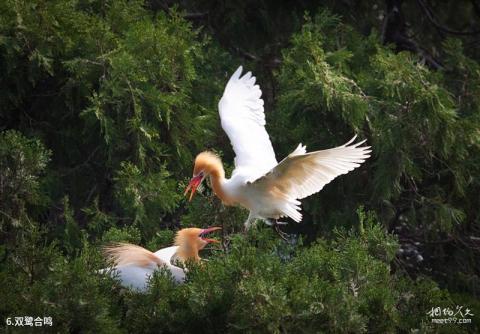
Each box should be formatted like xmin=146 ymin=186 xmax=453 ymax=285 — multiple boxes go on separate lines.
xmin=0 ymin=218 xmax=464 ymax=333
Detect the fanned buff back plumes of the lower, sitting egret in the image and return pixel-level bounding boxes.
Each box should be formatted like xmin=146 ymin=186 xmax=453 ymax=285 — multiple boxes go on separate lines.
xmin=103 ymin=243 xmax=164 ymax=267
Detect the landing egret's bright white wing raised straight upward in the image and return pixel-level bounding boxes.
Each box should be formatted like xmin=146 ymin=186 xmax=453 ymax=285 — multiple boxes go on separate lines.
xmin=218 ymin=66 xmax=277 ymax=181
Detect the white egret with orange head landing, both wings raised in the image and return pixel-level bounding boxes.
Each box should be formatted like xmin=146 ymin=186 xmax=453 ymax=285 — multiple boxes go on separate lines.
xmin=185 ymin=66 xmax=371 ymax=229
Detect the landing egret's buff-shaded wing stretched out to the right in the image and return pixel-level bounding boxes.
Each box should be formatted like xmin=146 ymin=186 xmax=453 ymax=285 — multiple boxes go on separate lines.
xmin=252 ymin=136 xmax=371 ymax=221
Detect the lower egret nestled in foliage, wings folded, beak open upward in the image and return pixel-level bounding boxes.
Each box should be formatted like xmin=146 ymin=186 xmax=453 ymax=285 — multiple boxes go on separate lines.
xmin=101 ymin=227 xmax=220 ymax=291
